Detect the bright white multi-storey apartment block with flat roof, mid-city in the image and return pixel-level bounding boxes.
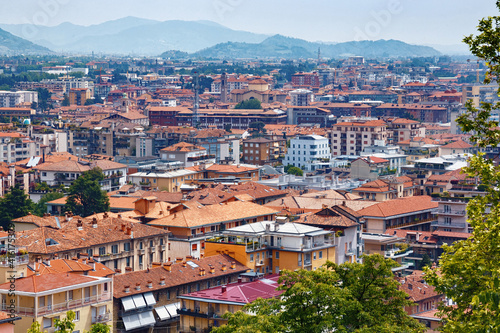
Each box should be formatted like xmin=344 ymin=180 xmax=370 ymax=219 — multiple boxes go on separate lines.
xmin=283 ymin=135 xmax=332 ymax=171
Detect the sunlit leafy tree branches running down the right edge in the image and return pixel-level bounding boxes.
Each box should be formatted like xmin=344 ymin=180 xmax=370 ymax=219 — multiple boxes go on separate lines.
xmin=426 ymin=1 xmax=500 ymax=333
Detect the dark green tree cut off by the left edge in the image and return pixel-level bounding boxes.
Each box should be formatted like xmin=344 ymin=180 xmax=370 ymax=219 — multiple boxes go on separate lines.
xmin=0 ymin=184 xmax=35 ymax=229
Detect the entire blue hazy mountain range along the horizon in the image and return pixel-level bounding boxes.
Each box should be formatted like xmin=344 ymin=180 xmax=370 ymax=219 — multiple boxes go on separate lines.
xmin=0 ymin=17 xmax=446 ymax=58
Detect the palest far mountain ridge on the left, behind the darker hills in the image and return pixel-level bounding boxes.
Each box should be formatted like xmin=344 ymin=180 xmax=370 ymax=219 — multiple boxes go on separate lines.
xmin=0 ymin=17 xmax=268 ymax=55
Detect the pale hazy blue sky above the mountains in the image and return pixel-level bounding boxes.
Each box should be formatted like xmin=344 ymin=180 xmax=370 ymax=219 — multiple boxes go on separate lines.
xmin=0 ymin=0 xmax=498 ymax=44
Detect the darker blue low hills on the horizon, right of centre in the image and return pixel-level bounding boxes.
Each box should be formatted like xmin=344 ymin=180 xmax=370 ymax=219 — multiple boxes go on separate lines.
xmin=193 ymin=35 xmax=440 ymax=59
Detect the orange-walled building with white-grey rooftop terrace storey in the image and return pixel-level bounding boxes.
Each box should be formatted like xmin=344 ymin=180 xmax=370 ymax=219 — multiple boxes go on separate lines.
xmin=205 ymin=217 xmax=336 ymax=274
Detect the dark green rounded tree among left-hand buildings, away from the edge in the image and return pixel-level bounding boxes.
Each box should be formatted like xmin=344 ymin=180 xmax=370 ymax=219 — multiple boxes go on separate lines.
xmin=66 ymin=168 xmax=109 ymax=217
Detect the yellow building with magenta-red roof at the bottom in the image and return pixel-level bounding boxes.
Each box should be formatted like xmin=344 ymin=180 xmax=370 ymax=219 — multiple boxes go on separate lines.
xmin=179 ymin=275 xmax=283 ymax=332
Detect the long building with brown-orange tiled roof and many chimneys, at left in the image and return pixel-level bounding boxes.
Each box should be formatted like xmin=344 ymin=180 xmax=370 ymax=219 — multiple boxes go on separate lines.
xmin=16 ymin=213 xmax=168 ymax=271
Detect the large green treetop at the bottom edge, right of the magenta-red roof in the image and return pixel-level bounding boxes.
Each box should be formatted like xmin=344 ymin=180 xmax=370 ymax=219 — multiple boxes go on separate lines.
xmin=212 ymin=254 xmax=425 ymax=333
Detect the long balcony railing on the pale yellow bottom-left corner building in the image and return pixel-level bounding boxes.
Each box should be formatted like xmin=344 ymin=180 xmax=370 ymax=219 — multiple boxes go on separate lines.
xmin=2 ymin=293 xmax=112 ymax=317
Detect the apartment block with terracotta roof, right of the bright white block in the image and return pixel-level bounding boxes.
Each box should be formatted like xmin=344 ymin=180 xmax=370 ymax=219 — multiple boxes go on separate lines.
xmin=330 ymin=120 xmax=388 ymax=156
